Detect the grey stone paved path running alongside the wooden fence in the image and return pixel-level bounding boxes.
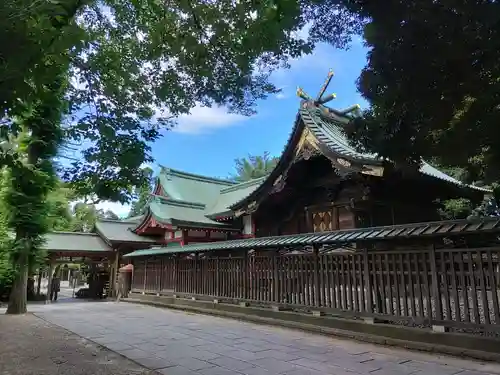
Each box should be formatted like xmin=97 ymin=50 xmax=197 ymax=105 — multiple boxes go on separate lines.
xmin=31 ymin=302 xmax=500 ymax=375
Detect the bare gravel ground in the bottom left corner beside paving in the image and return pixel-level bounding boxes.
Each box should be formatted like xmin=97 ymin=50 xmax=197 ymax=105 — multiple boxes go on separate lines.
xmin=0 ymin=314 xmax=156 ymax=375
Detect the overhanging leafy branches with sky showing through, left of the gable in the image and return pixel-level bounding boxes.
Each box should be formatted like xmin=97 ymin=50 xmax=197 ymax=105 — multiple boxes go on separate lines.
xmin=58 ymin=0 xmax=310 ymax=202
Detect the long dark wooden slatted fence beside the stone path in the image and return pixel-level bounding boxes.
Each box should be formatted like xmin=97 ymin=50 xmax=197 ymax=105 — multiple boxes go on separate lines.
xmin=132 ymin=248 xmax=500 ymax=330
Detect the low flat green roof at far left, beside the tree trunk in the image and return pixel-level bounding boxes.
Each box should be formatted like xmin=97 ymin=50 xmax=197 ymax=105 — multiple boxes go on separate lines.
xmin=42 ymin=232 xmax=112 ymax=253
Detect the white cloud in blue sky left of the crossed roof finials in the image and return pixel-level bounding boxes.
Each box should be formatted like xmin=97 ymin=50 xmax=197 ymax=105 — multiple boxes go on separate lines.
xmin=172 ymin=105 xmax=248 ymax=134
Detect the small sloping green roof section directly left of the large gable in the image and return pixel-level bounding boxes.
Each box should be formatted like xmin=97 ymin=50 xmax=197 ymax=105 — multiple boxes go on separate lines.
xmin=207 ymin=176 xmax=267 ymax=217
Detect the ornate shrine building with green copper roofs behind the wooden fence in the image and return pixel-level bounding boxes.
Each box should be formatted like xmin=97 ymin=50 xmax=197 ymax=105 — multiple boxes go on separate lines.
xmin=41 ymin=74 xmax=489 ymax=300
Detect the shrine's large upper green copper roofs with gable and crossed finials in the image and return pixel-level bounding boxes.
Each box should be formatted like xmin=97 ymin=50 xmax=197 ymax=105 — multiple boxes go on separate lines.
xmin=136 ymin=72 xmax=488 ymax=234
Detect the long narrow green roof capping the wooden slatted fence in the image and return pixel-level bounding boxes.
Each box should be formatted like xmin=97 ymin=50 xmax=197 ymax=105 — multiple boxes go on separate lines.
xmin=126 ymin=218 xmax=500 ymax=257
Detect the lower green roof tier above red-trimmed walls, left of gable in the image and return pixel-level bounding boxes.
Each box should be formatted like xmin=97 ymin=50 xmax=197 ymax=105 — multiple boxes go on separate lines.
xmin=149 ymin=196 xmax=235 ymax=229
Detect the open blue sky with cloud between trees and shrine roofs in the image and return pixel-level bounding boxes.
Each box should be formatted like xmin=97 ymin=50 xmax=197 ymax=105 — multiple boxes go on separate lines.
xmin=101 ymin=41 xmax=367 ymax=216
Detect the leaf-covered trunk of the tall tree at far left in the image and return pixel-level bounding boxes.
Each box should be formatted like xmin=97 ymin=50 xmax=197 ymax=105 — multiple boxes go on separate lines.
xmin=2 ymin=70 xmax=66 ymax=313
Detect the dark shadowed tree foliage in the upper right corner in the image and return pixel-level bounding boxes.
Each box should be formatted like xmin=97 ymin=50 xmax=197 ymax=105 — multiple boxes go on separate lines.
xmin=335 ymin=0 xmax=500 ymax=184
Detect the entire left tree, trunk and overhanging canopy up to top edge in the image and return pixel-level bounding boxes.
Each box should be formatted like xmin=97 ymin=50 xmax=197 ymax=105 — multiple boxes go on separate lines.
xmin=0 ymin=0 xmax=322 ymax=313
